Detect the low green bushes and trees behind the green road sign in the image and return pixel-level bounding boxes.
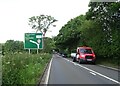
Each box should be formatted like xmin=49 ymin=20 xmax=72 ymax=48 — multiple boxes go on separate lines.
xmin=0 ymin=37 xmax=55 ymax=54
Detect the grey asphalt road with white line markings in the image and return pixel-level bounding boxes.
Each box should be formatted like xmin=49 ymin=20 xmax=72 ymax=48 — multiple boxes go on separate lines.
xmin=48 ymin=54 xmax=120 ymax=85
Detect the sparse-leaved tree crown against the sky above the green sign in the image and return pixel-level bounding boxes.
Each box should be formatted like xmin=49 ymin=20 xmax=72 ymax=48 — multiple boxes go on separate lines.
xmin=29 ymin=15 xmax=57 ymax=36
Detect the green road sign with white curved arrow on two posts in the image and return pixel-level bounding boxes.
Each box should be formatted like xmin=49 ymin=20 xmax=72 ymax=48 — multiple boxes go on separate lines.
xmin=24 ymin=33 xmax=43 ymax=49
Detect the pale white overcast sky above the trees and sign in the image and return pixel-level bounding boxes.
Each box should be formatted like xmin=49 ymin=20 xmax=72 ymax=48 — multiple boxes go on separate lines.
xmin=0 ymin=0 xmax=90 ymax=43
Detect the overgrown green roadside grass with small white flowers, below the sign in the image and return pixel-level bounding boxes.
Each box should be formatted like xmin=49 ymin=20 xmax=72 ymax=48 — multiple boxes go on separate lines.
xmin=2 ymin=53 xmax=52 ymax=86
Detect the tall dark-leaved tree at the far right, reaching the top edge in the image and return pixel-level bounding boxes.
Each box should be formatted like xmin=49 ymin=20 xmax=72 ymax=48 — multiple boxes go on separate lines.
xmin=86 ymin=2 xmax=120 ymax=58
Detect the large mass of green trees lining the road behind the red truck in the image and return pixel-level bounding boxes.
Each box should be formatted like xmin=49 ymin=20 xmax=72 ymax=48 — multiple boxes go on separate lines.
xmin=55 ymin=2 xmax=120 ymax=62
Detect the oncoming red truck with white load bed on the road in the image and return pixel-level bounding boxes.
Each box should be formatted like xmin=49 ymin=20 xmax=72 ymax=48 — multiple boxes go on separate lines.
xmin=73 ymin=46 xmax=96 ymax=64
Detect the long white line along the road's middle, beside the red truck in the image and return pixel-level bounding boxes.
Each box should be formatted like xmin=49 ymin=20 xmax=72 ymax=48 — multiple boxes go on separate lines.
xmin=64 ymin=58 xmax=120 ymax=84
